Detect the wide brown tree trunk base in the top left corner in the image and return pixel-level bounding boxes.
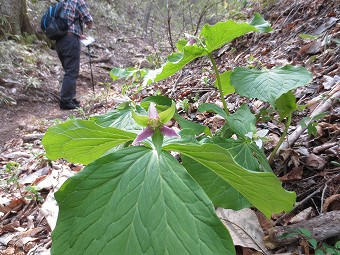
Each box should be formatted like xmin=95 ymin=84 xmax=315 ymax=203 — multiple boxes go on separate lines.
xmin=0 ymin=0 xmax=35 ymax=36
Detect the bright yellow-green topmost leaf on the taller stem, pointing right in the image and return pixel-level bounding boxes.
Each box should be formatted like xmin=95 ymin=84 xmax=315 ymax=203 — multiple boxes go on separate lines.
xmin=201 ymin=20 xmax=258 ymax=52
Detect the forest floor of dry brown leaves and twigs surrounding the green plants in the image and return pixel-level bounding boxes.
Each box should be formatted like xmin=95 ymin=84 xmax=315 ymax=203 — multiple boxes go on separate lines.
xmin=0 ymin=0 xmax=340 ymax=255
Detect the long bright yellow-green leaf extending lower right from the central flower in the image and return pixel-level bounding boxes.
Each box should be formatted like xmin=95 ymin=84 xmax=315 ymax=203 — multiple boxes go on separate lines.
xmin=164 ymin=144 xmax=296 ymax=217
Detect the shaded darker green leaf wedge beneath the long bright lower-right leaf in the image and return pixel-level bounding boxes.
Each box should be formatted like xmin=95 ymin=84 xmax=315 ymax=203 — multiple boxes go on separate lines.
xmin=181 ymin=155 xmax=251 ymax=210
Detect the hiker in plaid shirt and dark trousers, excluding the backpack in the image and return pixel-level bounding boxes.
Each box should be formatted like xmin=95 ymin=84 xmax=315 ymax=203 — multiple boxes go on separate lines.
xmin=56 ymin=0 xmax=93 ymax=110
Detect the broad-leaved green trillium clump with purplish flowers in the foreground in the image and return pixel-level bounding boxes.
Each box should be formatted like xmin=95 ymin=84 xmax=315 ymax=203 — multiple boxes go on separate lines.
xmin=42 ymin=14 xmax=311 ymax=255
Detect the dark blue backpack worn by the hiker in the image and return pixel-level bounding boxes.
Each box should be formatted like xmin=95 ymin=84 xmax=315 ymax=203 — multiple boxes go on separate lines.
xmin=40 ymin=1 xmax=69 ymax=40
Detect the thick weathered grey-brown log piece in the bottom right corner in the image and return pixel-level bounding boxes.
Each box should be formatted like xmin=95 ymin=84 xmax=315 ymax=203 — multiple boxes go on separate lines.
xmin=264 ymin=211 xmax=340 ymax=249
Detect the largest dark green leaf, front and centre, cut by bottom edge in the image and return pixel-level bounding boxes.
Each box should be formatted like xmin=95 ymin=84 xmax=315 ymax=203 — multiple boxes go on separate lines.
xmin=52 ymin=147 xmax=235 ymax=255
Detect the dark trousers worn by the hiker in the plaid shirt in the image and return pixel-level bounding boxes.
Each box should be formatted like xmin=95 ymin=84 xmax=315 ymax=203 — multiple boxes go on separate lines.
xmin=56 ymin=34 xmax=80 ymax=102
